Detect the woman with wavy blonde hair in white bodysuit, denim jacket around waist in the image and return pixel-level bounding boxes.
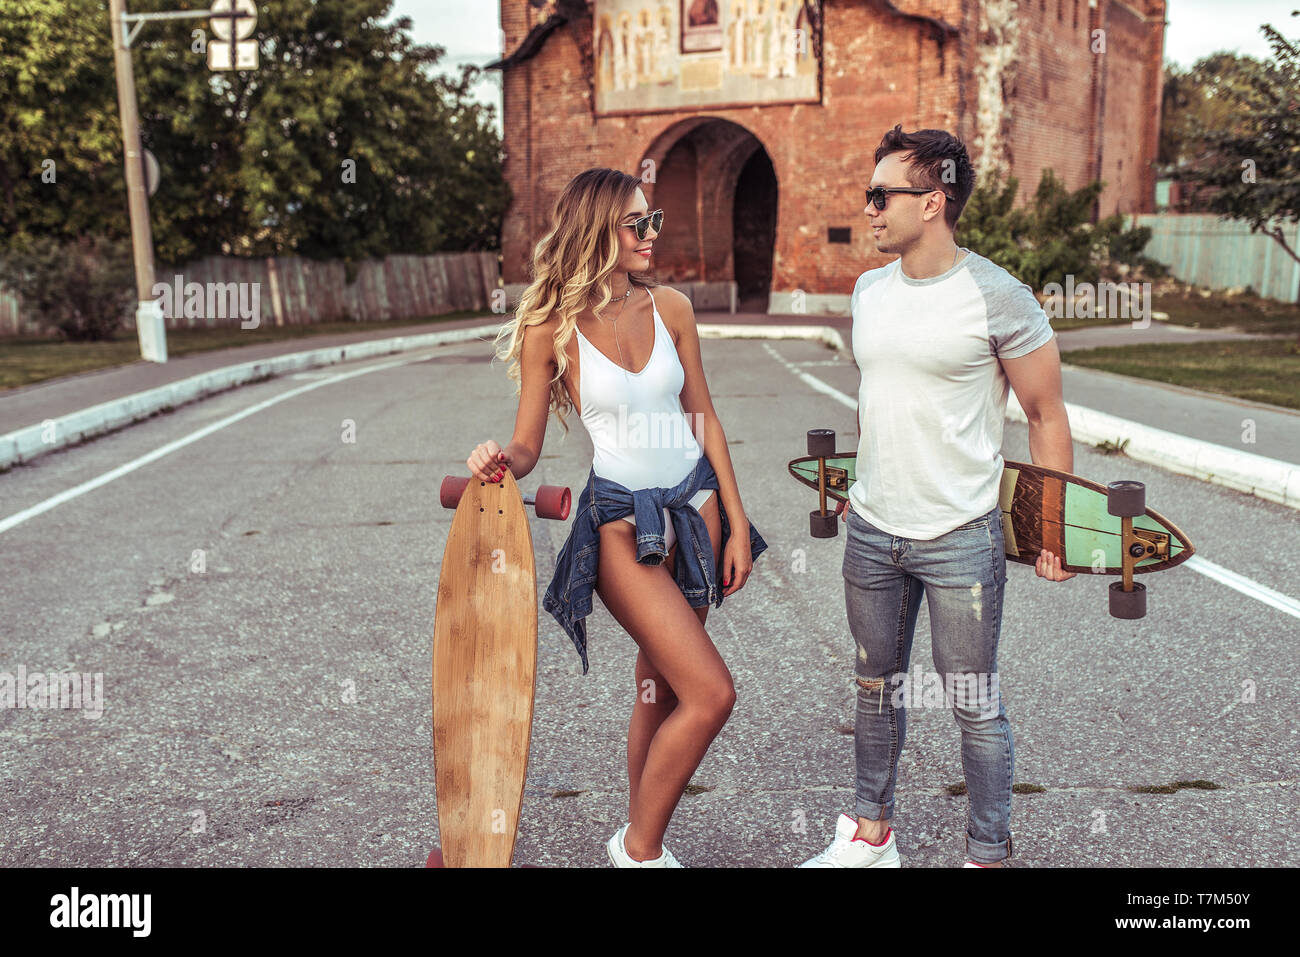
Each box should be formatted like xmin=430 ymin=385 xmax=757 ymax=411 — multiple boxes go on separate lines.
xmin=467 ymin=169 xmax=767 ymax=867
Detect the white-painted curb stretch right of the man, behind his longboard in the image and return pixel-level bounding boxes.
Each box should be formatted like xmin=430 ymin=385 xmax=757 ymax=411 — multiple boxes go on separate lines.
xmin=1006 ymin=391 xmax=1300 ymax=508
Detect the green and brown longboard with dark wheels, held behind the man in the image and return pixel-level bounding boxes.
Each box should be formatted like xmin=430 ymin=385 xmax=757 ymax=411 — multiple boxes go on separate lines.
xmin=789 ymin=429 xmax=1195 ymax=618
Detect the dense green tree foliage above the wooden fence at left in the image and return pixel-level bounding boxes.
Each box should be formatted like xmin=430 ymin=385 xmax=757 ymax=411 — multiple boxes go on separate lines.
xmin=0 ymin=0 xmax=510 ymax=264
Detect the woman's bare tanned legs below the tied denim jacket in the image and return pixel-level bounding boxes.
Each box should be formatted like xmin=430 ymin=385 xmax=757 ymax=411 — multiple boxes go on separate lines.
xmin=597 ymin=497 xmax=736 ymax=861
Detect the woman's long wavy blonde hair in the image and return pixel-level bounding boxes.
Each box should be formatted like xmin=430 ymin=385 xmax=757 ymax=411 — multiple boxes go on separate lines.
xmin=495 ymin=168 xmax=659 ymax=436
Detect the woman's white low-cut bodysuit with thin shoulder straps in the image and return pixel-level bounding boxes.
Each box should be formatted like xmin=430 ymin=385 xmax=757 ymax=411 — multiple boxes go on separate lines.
xmin=577 ymin=290 xmax=714 ymax=538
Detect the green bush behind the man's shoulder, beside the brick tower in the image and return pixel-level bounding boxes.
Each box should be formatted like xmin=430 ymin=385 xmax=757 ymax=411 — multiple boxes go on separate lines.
xmin=957 ymin=169 xmax=1164 ymax=290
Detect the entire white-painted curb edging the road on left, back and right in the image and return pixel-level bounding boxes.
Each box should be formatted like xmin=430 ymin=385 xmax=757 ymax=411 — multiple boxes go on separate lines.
xmin=0 ymin=322 xmax=1300 ymax=510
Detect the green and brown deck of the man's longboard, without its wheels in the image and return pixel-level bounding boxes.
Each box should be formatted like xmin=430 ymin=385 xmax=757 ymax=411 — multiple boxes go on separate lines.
xmin=789 ymin=452 xmax=1195 ymax=575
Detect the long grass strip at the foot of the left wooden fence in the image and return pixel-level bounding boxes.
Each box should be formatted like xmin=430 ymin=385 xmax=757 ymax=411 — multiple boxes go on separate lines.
xmin=0 ymin=309 xmax=504 ymax=390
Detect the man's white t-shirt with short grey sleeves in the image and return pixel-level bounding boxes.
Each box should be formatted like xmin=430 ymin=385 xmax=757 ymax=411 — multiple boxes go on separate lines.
xmin=849 ymin=248 xmax=1054 ymax=541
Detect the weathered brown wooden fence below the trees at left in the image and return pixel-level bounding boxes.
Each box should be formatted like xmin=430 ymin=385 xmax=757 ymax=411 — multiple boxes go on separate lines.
xmin=0 ymin=252 xmax=501 ymax=335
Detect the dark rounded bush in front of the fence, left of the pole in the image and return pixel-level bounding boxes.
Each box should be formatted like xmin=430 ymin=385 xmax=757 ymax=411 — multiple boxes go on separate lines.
xmin=0 ymin=237 xmax=135 ymax=341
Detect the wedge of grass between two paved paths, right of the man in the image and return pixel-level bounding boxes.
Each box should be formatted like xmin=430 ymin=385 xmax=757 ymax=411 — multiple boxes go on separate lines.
xmin=1061 ymin=339 xmax=1300 ymax=408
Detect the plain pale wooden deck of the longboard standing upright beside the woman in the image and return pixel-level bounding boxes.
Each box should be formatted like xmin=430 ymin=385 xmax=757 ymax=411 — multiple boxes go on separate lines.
xmin=433 ymin=468 xmax=537 ymax=867
